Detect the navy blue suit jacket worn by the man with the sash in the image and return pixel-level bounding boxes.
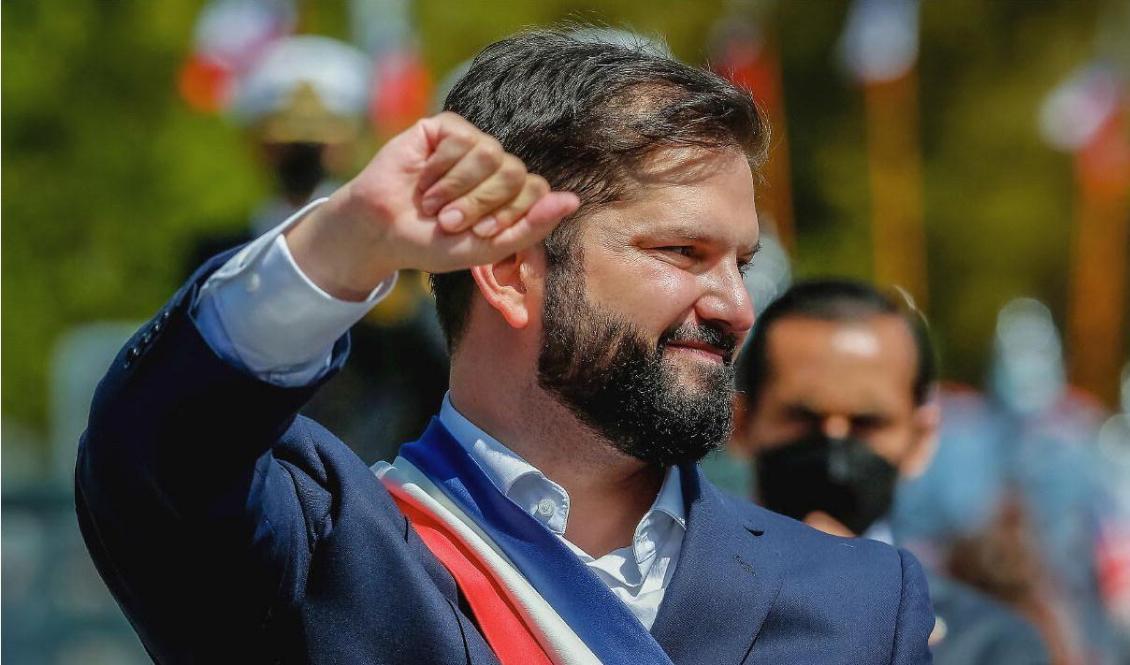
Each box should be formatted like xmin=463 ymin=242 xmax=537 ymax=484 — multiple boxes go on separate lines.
xmin=76 ymin=257 xmax=933 ymax=665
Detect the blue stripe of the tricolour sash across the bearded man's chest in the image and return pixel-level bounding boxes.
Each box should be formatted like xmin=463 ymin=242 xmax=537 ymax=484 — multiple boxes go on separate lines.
xmin=400 ymin=418 xmax=671 ymax=665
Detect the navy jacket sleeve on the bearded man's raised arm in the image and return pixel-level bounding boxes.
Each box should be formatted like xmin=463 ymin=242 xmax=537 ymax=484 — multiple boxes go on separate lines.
xmin=76 ymin=253 xmax=348 ymax=662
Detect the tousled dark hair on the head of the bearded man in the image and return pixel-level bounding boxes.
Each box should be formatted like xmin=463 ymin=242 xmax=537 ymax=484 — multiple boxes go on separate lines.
xmin=432 ymin=28 xmax=768 ymax=347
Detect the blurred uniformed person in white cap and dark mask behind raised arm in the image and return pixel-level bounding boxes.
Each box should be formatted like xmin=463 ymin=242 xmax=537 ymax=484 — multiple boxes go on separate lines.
xmin=186 ymin=27 xmax=447 ymax=463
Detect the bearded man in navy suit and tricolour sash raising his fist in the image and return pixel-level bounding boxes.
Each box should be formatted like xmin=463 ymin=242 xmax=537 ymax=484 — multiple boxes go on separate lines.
xmin=77 ymin=32 xmax=932 ymax=665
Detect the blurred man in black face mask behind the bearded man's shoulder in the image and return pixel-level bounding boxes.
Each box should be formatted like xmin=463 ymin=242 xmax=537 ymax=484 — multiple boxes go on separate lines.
xmin=731 ymin=279 xmax=1050 ymax=665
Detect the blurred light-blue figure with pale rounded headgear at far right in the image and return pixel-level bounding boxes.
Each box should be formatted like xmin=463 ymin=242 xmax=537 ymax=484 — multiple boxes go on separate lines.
xmin=982 ymin=297 xmax=1130 ymax=665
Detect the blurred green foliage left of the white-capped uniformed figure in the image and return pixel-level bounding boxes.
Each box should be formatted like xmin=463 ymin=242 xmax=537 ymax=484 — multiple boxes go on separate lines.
xmin=2 ymin=0 xmax=263 ymax=434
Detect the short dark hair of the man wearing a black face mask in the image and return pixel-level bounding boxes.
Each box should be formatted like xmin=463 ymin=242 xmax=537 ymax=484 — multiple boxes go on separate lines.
xmin=739 ymin=279 xmax=938 ymax=405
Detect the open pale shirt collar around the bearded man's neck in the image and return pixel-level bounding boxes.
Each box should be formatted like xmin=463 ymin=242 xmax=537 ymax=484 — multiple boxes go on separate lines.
xmin=440 ymin=392 xmax=687 ymax=547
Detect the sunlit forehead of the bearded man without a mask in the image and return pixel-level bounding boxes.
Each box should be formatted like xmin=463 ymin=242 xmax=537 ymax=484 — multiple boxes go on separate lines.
xmin=586 ymin=149 xmax=758 ymax=248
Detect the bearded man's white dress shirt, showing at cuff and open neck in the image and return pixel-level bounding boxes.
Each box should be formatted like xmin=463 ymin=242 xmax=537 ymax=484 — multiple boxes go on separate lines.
xmin=193 ymin=199 xmax=686 ymax=629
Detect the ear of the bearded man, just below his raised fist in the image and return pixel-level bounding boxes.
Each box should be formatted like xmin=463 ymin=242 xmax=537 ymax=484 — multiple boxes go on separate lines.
xmin=471 ymin=248 xmax=545 ymax=329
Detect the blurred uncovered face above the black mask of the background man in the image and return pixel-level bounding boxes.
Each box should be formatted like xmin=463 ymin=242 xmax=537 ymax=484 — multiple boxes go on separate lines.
xmin=745 ymin=316 xmax=932 ymax=474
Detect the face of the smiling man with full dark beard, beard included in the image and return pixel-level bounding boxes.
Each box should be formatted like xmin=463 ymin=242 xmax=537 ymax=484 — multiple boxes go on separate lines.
xmin=538 ymin=152 xmax=758 ymax=465
